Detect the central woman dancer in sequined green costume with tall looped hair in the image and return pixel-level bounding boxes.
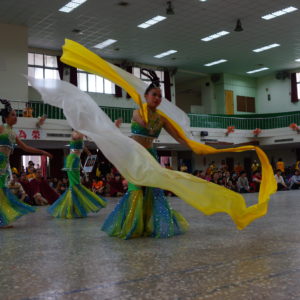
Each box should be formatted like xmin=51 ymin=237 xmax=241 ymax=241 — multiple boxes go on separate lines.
xmin=102 ymin=70 xmax=188 ymax=239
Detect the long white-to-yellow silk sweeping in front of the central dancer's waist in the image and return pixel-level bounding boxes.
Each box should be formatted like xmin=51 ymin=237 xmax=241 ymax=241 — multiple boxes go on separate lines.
xmin=29 ymin=78 xmax=275 ymax=229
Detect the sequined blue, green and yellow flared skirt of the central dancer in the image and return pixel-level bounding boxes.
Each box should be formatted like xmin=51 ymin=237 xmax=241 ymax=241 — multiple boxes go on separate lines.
xmin=102 ymin=149 xmax=188 ymax=239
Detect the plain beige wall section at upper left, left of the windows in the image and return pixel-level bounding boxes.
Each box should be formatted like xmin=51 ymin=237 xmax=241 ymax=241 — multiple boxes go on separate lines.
xmin=0 ymin=24 xmax=28 ymax=101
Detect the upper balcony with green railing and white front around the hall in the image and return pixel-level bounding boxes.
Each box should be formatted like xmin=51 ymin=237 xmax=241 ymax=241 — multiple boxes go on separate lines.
xmin=12 ymin=101 xmax=300 ymax=146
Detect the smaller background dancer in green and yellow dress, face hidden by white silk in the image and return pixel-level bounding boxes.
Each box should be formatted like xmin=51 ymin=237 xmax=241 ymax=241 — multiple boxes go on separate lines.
xmin=48 ymin=131 xmax=106 ymax=219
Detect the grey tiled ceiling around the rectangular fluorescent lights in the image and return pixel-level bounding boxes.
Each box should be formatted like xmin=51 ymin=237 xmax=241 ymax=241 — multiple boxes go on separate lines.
xmin=0 ymin=0 xmax=300 ymax=78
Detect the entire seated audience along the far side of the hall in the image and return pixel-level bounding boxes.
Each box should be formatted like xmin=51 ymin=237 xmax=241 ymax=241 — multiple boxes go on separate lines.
xmin=8 ymin=155 xmax=300 ymax=205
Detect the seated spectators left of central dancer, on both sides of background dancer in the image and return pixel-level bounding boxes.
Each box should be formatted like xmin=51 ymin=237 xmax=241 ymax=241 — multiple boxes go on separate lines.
xmin=8 ymin=161 xmax=127 ymax=205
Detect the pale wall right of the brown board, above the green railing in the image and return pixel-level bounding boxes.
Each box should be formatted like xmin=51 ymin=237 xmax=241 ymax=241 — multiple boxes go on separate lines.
xmin=256 ymin=74 xmax=300 ymax=114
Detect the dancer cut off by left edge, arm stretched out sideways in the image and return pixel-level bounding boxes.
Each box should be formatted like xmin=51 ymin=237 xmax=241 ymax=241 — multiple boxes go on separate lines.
xmin=0 ymin=99 xmax=52 ymax=228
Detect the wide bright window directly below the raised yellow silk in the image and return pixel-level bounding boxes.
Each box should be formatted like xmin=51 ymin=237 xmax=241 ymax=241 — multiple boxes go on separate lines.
xmin=77 ymin=69 xmax=115 ymax=94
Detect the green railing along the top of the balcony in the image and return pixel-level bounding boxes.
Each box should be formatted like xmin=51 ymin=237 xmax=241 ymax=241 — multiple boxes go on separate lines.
xmin=12 ymin=101 xmax=300 ymax=130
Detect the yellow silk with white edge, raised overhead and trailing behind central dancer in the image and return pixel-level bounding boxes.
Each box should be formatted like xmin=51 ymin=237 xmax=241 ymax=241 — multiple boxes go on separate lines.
xmin=61 ymin=39 xmax=277 ymax=211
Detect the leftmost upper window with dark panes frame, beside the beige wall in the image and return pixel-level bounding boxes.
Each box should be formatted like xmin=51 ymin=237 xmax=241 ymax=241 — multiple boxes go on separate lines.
xmin=28 ymin=53 xmax=59 ymax=79
